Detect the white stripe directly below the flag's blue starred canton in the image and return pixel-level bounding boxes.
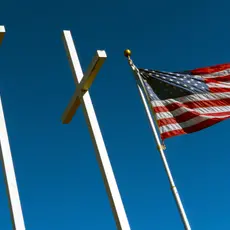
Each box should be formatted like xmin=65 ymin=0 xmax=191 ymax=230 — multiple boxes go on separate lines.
xmin=151 ymin=92 xmax=230 ymax=107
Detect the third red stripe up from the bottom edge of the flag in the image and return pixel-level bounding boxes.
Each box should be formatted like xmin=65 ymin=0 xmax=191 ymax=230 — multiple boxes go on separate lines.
xmin=153 ymin=98 xmax=230 ymax=113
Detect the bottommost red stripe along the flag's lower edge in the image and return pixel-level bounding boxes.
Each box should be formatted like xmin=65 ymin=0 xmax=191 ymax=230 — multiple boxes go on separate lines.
xmin=161 ymin=118 xmax=227 ymax=140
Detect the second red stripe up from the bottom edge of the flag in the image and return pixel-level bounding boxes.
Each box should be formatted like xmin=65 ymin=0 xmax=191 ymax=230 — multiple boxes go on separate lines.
xmin=157 ymin=111 xmax=230 ymax=127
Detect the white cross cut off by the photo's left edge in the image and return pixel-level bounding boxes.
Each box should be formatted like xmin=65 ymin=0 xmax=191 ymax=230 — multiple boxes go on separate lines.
xmin=0 ymin=26 xmax=25 ymax=230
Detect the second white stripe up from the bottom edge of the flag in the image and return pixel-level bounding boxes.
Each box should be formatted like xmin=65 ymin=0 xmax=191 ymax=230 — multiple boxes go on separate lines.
xmin=156 ymin=106 xmax=230 ymax=120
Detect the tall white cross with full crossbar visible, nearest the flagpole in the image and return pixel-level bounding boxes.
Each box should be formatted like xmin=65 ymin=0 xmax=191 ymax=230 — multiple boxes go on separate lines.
xmin=62 ymin=31 xmax=130 ymax=230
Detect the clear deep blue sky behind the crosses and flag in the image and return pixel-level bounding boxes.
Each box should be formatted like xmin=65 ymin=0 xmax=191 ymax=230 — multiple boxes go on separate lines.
xmin=0 ymin=0 xmax=230 ymax=230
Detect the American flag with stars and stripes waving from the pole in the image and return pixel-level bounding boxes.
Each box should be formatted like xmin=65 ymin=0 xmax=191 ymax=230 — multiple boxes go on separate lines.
xmin=137 ymin=64 xmax=230 ymax=140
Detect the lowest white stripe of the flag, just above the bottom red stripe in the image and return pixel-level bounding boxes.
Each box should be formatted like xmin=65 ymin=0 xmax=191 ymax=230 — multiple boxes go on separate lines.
xmin=159 ymin=115 xmax=228 ymax=134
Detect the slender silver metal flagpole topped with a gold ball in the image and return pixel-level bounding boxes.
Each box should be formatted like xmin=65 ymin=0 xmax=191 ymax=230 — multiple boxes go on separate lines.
xmin=124 ymin=50 xmax=191 ymax=230
